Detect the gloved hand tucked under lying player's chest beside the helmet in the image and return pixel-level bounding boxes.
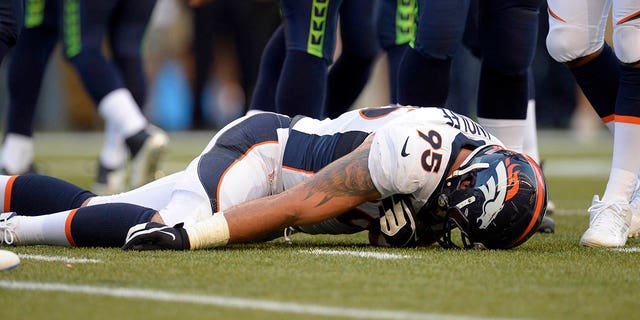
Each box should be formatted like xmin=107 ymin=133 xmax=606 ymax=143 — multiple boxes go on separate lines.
xmin=378 ymin=195 xmax=418 ymax=247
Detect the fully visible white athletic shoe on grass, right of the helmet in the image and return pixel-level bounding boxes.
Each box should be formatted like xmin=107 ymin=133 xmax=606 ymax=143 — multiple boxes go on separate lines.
xmin=580 ymin=195 xmax=631 ymax=248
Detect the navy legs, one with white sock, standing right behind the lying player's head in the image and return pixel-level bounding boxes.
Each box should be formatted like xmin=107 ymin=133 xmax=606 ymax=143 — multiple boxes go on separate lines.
xmin=397 ymin=0 xmax=540 ymax=155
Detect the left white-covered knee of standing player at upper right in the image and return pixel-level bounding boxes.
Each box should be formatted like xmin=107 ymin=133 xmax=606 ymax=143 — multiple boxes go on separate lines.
xmin=547 ymin=22 xmax=604 ymax=63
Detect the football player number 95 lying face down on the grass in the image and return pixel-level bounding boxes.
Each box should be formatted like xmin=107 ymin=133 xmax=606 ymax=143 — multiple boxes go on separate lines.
xmin=0 ymin=107 xmax=547 ymax=250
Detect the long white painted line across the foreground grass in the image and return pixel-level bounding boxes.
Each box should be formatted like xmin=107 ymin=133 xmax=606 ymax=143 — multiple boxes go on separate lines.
xmin=0 ymin=280 xmax=512 ymax=320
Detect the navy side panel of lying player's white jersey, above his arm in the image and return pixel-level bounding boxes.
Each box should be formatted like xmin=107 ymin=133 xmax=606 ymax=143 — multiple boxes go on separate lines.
xmin=282 ymin=130 xmax=369 ymax=172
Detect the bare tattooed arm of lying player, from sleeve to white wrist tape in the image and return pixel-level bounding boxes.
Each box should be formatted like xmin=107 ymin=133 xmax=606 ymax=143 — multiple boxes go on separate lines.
xmin=224 ymin=136 xmax=380 ymax=243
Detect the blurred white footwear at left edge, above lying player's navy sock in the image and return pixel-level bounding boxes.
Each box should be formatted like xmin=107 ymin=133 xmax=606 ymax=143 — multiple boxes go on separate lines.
xmin=0 ymin=133 xmax=34 ymax=174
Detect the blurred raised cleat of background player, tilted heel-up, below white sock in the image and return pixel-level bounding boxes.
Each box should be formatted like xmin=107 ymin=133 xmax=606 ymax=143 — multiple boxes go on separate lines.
xmin=125 ymin=125 xmax=169 ymax=188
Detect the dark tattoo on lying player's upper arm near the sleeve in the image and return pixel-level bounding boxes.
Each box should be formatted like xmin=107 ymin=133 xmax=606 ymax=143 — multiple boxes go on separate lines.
xmin=305 ymin=147 xmax=377 ymax=207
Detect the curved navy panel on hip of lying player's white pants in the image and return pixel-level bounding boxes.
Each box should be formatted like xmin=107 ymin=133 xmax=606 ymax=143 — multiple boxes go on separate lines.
xmin=198 ymin=113 xmax=291 ymax=212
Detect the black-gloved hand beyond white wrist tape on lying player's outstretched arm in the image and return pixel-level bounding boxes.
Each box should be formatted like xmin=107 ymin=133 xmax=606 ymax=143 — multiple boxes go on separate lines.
xmin=122 ymin=222 xmax=191 ymax=250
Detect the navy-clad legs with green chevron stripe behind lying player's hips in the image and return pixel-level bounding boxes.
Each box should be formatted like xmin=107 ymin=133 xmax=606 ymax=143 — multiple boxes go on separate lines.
xmin=251 ymin=0 xmax=380 ymax=118
